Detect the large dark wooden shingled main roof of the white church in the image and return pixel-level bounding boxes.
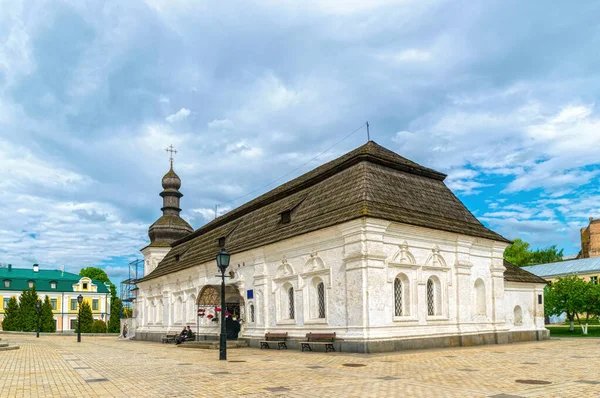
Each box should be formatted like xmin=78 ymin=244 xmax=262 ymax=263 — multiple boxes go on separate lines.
xmin=143 ymin=141 xmax=509 ymax=280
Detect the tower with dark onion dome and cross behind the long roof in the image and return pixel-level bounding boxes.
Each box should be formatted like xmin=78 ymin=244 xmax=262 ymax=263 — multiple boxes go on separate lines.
xmin=141 ymin=145 xmax=194 ymax=276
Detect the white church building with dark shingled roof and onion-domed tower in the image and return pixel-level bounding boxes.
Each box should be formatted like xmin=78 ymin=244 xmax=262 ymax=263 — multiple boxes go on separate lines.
xmin=134 ymin=141 xmax=549 ymax=352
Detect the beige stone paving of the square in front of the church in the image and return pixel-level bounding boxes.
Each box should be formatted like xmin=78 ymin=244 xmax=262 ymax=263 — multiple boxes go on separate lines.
xmin=0 ymin=335 xmax=600 ymax=398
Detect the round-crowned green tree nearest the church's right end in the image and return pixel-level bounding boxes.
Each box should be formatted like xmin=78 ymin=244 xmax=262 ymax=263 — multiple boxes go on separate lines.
xmin=544 ymin=275 xmax=590 ymax=331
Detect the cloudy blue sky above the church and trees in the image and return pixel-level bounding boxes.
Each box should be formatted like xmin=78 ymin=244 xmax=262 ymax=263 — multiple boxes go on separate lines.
xmin=0 ymin=0 xmax=600 ymax=281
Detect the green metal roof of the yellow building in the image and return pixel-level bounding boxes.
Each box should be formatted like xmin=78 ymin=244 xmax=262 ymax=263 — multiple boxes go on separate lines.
xmin=0 ymin=268 xmax=110 ymax=293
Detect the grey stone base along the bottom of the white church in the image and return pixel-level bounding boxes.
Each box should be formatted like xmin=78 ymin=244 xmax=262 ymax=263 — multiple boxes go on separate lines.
xmin=135 ymin=329 xmax=550 ymax=354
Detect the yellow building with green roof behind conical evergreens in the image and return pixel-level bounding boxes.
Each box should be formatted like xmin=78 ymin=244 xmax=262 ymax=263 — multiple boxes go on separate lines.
xmin=0 ymin=264 xmax=110 ymax=332
